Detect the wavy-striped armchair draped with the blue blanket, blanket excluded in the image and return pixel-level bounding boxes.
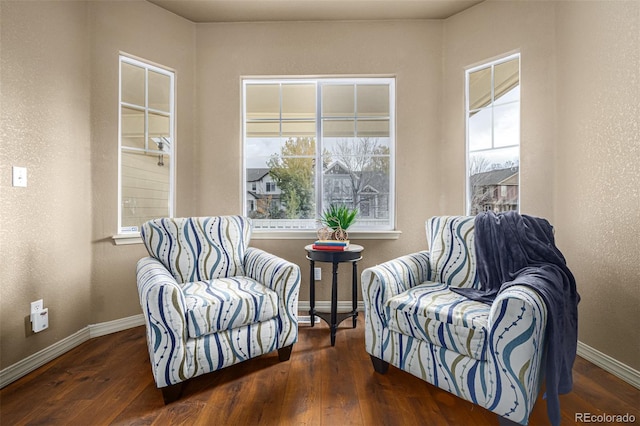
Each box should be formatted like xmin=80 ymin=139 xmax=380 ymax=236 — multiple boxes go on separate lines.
xmin=362 ymin=216 xmax=547 ymax=425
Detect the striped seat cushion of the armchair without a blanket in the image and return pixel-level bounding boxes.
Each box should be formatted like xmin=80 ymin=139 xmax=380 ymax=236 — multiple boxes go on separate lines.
xmin=182 ymin=277 xmax=278 ymax=337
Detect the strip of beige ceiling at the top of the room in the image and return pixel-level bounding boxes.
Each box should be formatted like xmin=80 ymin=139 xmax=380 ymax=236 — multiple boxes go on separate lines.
xmin=148 ymin=0 xmax=483 ymax=22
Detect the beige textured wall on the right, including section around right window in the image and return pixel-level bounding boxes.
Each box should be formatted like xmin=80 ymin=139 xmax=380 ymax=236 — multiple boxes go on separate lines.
xmin=442 ymin=1 xmax=640 ymax=369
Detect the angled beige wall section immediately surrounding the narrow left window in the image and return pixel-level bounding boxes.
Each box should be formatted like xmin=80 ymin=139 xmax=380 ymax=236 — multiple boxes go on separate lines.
xmin=89 ymin=1 xmax=197 ymax=323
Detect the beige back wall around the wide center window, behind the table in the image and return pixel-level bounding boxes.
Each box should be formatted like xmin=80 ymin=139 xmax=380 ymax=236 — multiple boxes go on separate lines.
xmin=196 ymin=21 xmax=442 ymax=301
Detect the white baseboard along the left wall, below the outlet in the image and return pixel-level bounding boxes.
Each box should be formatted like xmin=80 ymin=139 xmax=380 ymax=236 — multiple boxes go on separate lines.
xmin=0 ymin=314 xmax=144 ymax=389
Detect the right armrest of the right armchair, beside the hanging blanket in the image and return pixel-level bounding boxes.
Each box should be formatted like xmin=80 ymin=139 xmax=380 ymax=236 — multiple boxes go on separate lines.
xmin=487 ymin=285 xmax=547 ymax=423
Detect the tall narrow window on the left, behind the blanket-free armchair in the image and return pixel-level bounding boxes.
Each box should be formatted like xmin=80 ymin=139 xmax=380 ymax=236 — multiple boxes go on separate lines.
xmin=118 ymin=55 xmax=175 ymax=234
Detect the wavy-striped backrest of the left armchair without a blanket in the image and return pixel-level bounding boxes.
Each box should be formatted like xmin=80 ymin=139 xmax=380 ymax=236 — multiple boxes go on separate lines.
xmin=141 ymin=216 xmax=251 ymax=283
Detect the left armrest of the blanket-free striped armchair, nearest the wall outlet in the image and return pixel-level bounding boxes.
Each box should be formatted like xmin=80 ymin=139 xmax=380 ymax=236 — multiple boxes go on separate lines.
xmin=136 ymin=257 xmax=195 ymax=388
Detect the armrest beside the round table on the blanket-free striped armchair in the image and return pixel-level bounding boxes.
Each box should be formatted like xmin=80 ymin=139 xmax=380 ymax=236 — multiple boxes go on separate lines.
xmin=244 ymin=247 xmax=300 ymax=347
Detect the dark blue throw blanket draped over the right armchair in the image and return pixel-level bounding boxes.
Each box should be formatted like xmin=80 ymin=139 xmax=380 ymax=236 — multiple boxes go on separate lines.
xmin=451 ymin=212 xmax=580 ymax=425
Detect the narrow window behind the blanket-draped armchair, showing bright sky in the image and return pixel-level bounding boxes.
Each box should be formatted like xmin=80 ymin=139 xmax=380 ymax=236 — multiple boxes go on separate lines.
xmin=466 ymin=54 xmax=520 ymax=215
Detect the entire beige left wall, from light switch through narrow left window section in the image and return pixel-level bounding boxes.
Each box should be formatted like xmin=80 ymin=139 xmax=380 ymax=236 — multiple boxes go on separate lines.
xmin=0 ymin=1 xmax=197 ymax=368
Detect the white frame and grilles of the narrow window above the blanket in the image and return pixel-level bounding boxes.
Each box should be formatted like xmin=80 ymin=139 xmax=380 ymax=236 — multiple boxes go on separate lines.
xmin=465 ymin=52 xmax=522 ymax=214
